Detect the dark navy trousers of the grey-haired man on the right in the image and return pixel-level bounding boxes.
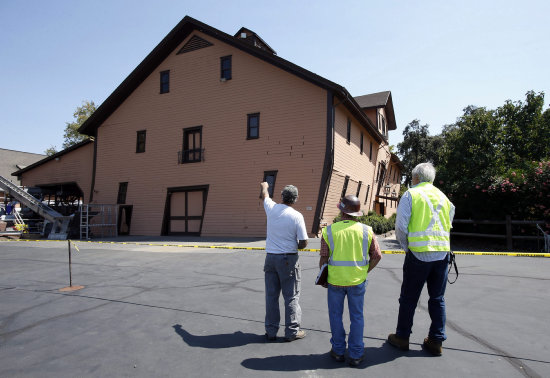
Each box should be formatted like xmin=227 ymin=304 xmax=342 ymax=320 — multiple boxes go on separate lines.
xmin=395 ymin=252 xmax=449 ymax=342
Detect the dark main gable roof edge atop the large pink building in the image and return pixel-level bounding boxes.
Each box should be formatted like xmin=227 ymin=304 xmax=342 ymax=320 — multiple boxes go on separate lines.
xmin=78 ymin=16 xmax=384 ymax=142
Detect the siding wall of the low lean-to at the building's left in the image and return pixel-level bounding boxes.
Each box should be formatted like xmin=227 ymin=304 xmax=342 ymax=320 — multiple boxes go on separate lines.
xmin=21 ymin=143 xmax=94 ymax=202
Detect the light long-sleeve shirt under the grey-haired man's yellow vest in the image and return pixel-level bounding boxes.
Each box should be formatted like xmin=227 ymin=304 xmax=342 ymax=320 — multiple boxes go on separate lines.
xmin=395 ymin=185 xmax=455 ymax=262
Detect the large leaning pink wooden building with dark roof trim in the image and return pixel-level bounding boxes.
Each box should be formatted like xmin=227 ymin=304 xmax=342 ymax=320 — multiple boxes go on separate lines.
xmin=14 ymin=17 xmax=401 ymax=236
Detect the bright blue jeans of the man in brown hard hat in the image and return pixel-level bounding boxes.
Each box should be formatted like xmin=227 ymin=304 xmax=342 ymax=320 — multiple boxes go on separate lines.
xmin=327 ymin=281 xmax=367 ymax=358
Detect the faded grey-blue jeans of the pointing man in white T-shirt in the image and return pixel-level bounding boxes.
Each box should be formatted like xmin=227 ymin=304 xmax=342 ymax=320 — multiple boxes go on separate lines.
xmin=264 ymin=253 xmax=302 ymax=337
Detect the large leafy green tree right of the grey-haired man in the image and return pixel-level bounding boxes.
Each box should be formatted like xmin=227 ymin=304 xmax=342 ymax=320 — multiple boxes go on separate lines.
xmin=436 ymin=91 xmax=550 ymax=219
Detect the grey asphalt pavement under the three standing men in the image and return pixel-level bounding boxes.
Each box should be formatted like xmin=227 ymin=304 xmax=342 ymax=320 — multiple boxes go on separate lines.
xmin=0 ymin=238 xmax=550 ymax=377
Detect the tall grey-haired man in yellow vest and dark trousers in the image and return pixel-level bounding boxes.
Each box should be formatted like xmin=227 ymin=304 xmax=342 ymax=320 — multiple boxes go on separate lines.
xmin=388 ymin=163 xmax=455 ymax=356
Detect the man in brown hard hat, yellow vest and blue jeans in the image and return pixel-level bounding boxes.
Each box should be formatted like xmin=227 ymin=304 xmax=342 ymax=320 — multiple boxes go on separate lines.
xmin=319 ymin=195 xmax=382 ymax=366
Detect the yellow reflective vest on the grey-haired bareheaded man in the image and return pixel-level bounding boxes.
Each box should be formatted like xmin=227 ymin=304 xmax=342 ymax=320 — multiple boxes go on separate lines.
xmin=408 ymin=182 xmax=451 ymax=252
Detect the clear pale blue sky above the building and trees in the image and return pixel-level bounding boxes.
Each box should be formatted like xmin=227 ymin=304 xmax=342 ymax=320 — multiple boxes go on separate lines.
xmin=0 ymin=0 xmax=550 ymax=153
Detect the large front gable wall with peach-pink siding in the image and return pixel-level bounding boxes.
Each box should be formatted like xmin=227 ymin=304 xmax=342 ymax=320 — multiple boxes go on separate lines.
xmin=94 ymin=33 xmax=327 ymax=236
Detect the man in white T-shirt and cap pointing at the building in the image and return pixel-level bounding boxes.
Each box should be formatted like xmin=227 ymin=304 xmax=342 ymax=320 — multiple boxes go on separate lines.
xmin=260 ymin=182 xmax=308 ymax=341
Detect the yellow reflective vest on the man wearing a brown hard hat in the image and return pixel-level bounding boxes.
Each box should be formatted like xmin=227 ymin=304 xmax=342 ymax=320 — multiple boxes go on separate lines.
xmin=323 ymin=220 xmax=373 ymax=286
